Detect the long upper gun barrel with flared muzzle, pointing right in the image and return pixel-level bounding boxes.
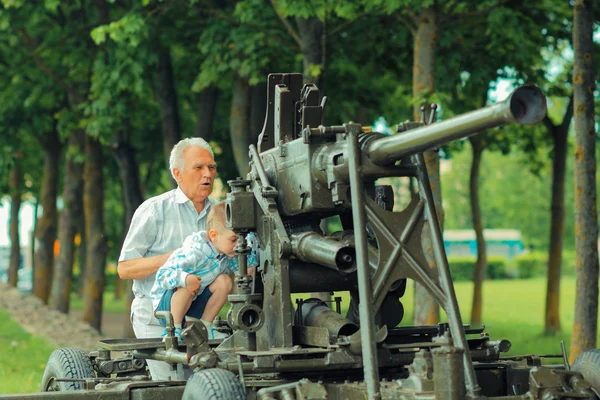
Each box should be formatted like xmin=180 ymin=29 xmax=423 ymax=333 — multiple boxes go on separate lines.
xmin=366 ymin=86 xmax=546 ymax=165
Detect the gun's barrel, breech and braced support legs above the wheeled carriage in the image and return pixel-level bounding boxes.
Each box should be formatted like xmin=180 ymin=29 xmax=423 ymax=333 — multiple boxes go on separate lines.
xmin=221 ymin=74 xmax=546 ymax=398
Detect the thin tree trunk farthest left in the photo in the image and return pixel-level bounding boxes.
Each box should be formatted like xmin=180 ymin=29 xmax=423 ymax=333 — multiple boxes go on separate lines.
xmin=8 ymin=151 xmax=23 ymax=287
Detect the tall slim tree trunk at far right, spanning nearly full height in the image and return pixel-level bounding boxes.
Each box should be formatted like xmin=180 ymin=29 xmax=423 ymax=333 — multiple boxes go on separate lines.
xmin=570 ymin=0 xmax=598 ymax=361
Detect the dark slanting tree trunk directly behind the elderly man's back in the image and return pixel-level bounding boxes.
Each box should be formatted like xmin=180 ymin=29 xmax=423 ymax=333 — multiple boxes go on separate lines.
xmin=113 ymin=132 xmax=144 ymax=337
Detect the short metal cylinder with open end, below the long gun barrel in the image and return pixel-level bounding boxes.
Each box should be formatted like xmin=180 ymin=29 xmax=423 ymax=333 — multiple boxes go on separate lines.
xmin=291 ymin=232 xmax=356 ymax=274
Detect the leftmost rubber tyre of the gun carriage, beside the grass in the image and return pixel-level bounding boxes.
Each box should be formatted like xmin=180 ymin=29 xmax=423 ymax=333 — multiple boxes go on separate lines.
xmin=40 ymin=348 xmax=96 ymax=392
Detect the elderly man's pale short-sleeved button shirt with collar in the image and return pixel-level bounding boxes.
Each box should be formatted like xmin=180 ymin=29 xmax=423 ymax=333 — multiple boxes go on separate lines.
xmin=119 ymin=187 xmax=213 ymax=297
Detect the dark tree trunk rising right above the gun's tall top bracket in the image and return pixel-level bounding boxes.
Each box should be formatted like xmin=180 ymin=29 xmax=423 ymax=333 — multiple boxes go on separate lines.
xmin=296 ymin=17 xmax=325 ymax=89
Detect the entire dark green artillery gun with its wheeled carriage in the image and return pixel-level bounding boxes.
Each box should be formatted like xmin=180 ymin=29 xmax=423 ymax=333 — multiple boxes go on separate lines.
xmin=22 ymin=74 xmax=599 ymax=400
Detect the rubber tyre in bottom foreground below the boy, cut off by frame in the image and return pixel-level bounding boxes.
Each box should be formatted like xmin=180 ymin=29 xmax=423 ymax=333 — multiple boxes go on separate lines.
xmin=182 ymin=368 xmax=246 ymax=400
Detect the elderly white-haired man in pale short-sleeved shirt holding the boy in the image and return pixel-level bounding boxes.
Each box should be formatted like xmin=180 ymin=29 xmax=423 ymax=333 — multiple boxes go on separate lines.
xmin=118 ymin=138 xmax=231 ymax=380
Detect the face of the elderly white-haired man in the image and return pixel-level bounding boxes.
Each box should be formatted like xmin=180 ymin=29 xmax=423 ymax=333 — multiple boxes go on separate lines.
xmin=173 ymin=146 xmax=217 ymax=203
